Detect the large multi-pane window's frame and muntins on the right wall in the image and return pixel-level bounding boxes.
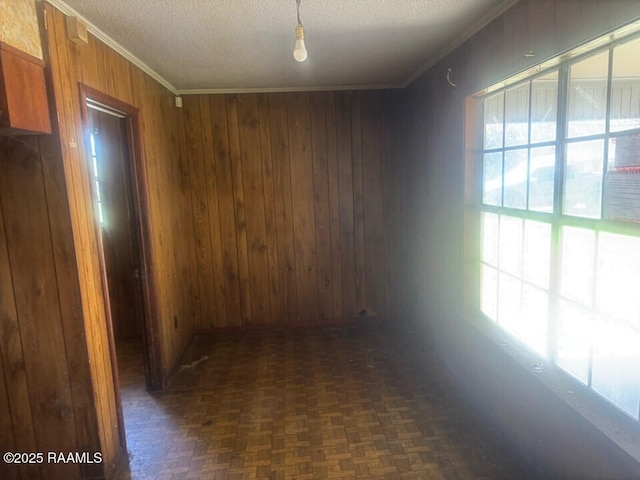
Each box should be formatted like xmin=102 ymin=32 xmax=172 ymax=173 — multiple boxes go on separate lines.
xmin=464 ymin=23 xmax=640 ymax=425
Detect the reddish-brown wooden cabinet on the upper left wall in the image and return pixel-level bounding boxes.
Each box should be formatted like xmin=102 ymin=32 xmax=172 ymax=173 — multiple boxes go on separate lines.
xmin=0 ymin=42 xmax=51 ymax=135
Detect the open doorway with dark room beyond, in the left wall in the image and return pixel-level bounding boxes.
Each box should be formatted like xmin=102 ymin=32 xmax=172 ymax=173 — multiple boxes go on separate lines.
xmin=80 ymin=84 xmax=162 ymax=402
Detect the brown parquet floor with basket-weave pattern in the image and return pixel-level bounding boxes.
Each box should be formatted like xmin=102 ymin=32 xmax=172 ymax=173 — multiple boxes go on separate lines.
xmin=118 ymin=323 xmax=533 ymax=480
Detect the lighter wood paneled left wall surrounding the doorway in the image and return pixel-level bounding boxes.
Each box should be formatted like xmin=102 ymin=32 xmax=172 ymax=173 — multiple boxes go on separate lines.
xmin=47 ymin=3 xmax=195 ymax=378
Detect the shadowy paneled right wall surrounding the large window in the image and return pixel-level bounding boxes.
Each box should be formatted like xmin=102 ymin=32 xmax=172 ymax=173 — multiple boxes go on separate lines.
xmin=393 ymin=0 xmax=640 ymax=478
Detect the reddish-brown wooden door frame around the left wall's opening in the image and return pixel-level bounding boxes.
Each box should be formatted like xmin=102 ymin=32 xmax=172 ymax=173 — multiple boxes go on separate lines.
xmin=78 ymin=83 xmax=163 ymax=396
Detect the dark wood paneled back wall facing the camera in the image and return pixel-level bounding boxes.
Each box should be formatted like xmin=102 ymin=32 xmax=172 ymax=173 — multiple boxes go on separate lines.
xmin=182 ymin=91 xmax=399 ymax=328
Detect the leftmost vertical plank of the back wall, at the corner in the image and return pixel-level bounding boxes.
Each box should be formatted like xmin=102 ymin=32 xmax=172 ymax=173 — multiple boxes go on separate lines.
xmin=183 ymin=95 xmax=216 ymax=328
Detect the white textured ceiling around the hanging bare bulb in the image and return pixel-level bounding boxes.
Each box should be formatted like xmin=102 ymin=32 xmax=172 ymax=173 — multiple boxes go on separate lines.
xmin=51 ymin=0 xmax=515 ymax=93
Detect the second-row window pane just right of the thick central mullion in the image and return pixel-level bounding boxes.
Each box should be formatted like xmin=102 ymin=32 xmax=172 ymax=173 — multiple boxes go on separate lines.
xmin=562 ymin=140 xmax=604 ymax=218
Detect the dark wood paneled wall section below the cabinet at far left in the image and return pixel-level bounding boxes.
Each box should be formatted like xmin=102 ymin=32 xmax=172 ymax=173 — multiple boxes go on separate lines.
xmin=0 ymin=136 xmax=102 ymax=479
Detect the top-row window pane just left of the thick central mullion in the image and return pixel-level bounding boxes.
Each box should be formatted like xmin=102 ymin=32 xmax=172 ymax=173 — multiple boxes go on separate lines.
xmin=531 ymin=72 xmax=558 ymax=143
